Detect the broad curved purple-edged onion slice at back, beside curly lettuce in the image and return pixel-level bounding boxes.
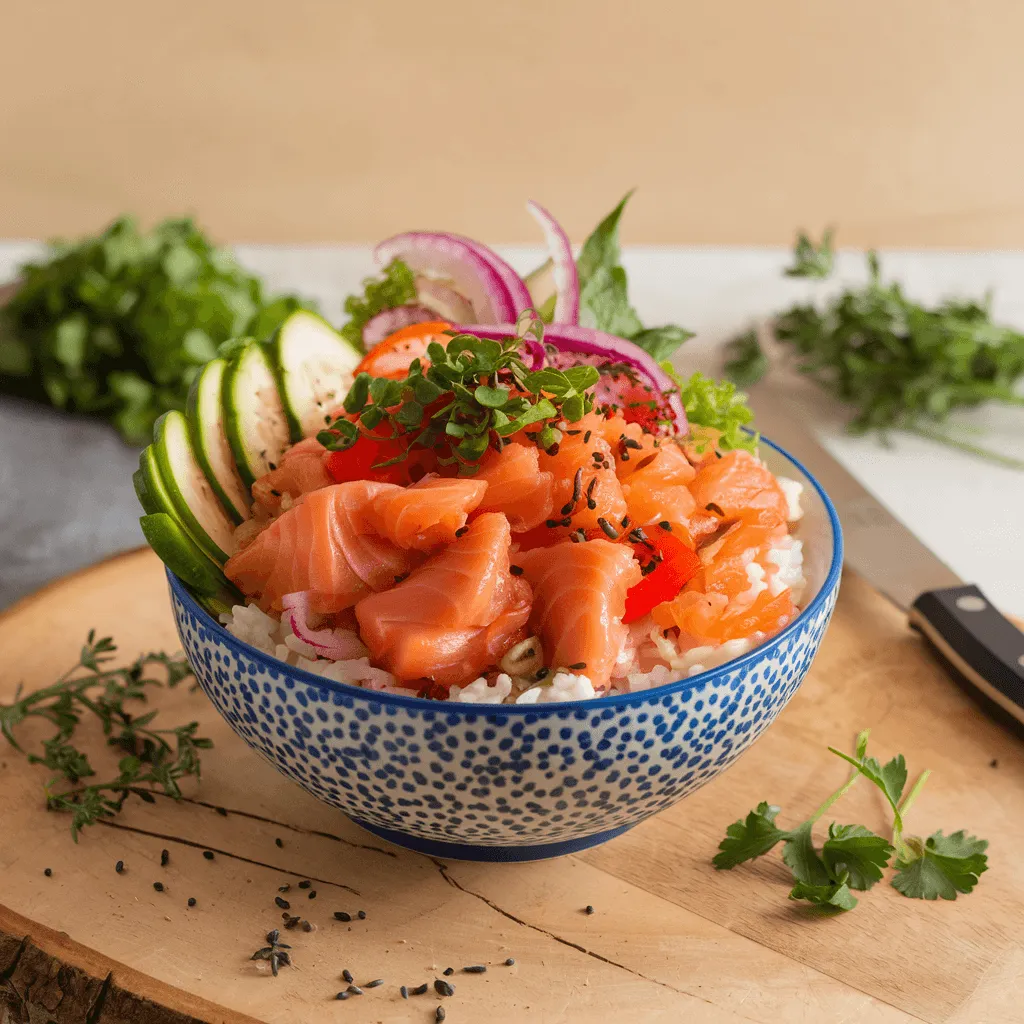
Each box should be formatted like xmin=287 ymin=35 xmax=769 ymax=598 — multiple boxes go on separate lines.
xmin=374 ymin=231 xmax=529 ymax=324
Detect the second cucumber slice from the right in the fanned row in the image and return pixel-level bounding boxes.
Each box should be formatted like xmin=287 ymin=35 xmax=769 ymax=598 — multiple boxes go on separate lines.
xmin=221 ymin=341 xmax=292 ymax=487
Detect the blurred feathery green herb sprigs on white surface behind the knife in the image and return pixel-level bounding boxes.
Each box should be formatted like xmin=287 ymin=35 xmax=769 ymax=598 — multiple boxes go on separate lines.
xmin=725 ymin=232 xmax=1024 ymax=469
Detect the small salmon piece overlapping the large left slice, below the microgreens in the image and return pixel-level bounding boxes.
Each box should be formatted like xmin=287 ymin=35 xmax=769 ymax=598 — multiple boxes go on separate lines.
xmin=369 ymin=475 xmax=487 ymax=551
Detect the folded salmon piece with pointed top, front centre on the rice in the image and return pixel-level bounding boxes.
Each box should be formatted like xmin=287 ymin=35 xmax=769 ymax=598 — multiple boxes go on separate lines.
xmin=355 ymin=512 xmax=531 ymax=685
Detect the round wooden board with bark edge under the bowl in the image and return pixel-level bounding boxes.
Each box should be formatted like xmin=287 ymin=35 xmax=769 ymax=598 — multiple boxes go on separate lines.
xmin=0 ymin=552 xmax=1024 ymax=1024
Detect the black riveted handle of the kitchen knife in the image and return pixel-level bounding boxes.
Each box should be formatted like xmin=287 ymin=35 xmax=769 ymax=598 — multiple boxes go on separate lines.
xmin=910 ymin=584 xmax=1024 ymax=722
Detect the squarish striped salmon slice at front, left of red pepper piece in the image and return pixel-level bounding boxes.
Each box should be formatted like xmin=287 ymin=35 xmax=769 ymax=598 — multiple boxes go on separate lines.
xmin=515 ymin=540 xmax=640 ymax=689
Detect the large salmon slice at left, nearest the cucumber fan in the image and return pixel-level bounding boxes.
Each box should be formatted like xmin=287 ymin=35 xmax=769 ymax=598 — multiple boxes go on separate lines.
xmin=224 ymin=480 xmax=423 ymax=614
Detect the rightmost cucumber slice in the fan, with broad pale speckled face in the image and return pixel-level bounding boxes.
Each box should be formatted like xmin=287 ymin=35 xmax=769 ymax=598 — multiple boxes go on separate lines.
xmin=270 ymin=309 xmax=361 ymax=441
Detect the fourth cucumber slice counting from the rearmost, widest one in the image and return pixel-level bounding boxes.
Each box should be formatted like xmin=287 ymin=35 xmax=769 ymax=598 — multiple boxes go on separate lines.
xmin=150 ymin=410 xmax=236 ymax=564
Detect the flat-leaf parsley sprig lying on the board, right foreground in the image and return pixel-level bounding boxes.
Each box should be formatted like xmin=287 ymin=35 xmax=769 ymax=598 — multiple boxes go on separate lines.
xmin=713 ymin=730 xmax=988 ymax=910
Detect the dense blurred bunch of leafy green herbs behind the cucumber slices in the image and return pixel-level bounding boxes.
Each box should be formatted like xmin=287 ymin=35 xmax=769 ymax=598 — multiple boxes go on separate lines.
xmin=0 ymin=217 xmax=313 ymax=443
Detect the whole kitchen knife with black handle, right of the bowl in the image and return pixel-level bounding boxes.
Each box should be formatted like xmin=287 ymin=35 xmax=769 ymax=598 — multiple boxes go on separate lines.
xmin=751 ymin=393 xmax=1024 ymax=723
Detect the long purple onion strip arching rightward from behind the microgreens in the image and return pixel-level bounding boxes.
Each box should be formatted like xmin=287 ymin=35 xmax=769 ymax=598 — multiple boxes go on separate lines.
xmin=459 ymin=324 xmax=689 ymax=434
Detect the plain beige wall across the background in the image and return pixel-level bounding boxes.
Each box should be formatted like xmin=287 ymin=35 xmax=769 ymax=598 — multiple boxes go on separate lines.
xmin=0 ymin=0 xmax=1024 ymax=248
